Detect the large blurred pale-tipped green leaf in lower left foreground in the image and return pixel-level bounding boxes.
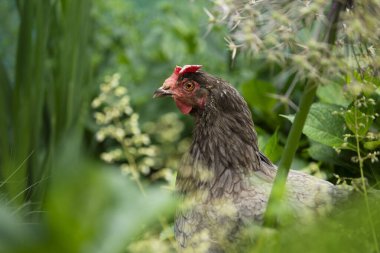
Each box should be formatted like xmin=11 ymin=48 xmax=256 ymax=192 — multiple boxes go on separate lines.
xmin=46 ymin=162 xmax=174 ymax=253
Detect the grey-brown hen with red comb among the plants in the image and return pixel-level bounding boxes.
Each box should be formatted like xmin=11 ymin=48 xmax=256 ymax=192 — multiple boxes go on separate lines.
xmin=154 ymin=65 xmax=346 ymax=252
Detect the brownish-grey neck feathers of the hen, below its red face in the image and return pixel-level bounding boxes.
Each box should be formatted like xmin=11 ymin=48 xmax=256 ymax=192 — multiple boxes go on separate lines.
xmin=177 ymin=80 xmax=260 ymax=196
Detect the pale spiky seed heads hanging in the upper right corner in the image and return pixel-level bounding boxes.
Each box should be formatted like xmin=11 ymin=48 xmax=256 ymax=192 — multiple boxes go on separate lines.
xmin=211 ymin=0 xmax=380 ymax=84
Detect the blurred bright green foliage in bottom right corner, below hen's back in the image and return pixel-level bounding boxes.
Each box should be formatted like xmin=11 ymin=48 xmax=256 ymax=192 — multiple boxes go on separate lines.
xmin=233 ymin=196 xmax=380 ymax=253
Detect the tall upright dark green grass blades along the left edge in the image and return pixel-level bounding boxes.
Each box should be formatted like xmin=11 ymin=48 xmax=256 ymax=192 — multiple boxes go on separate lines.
xmin=0 ymin=0 xmax=91 ymax=210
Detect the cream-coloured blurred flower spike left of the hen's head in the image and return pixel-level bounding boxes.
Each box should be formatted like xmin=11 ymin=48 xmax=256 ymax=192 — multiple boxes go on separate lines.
xmin=92 ymin=74 xmax=157 ymax=184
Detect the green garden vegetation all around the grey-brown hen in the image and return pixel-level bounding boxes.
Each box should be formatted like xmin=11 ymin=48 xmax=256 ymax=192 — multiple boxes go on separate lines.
xmin=0 ymin=0 xmax=380 ymax=252
